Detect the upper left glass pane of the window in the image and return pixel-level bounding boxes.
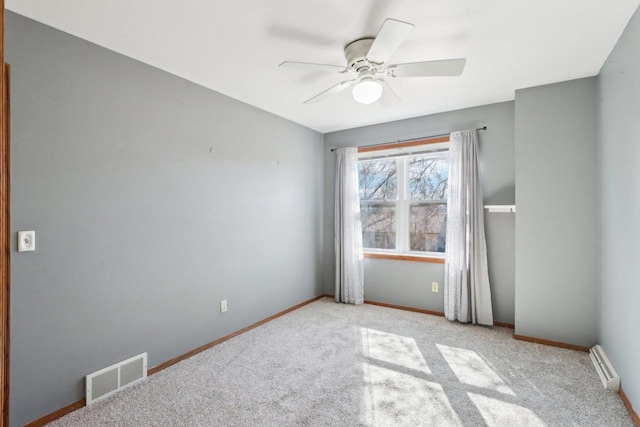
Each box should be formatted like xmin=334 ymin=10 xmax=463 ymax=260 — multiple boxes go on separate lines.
xmin=358 ymin=160 xmax=398 ymax=200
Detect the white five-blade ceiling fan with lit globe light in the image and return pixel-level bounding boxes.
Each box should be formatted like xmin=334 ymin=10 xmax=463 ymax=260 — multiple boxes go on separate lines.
xmin=280 ymin=19 xmax=467 ymax=107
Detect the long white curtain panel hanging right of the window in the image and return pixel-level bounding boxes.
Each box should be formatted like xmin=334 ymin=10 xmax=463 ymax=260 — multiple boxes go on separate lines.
xmin=444 ymin=130 xmax=493 ymax=325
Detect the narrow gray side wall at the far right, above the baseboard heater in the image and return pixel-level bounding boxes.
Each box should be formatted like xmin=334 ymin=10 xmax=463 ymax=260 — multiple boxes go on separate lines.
xmin=599 ymin=4 xmax=640 ymax=412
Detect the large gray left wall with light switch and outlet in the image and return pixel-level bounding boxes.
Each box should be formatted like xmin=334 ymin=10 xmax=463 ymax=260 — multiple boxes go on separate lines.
xmin=6 ymin=12 xmax=323 ymax=426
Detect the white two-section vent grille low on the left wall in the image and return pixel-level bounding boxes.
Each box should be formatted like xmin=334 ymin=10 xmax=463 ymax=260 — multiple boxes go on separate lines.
xmin=86 ymin=353 xmax=147 ymax=406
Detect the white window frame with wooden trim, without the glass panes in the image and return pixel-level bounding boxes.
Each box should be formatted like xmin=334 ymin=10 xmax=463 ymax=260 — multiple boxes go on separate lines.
xmin=358 ymin=136 xmax=449 ymax=263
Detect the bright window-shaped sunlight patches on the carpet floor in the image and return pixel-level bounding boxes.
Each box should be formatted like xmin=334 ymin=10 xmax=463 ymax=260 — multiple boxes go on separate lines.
xmin=360 ymin=328 xmax=545 ymax=427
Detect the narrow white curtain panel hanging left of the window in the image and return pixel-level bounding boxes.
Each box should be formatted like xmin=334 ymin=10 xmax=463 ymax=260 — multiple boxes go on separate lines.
xmin=335 ymin=148 xmax=364 ymax=304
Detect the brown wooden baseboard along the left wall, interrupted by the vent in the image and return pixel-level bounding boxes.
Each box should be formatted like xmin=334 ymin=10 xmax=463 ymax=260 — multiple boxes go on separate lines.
xmin=25 ymin=295 xmax=326 ymax=427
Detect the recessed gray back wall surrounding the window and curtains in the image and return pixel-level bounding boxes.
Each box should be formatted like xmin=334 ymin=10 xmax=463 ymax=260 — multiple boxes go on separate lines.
xmin=324 ymin=102 xmax=515 ymax=323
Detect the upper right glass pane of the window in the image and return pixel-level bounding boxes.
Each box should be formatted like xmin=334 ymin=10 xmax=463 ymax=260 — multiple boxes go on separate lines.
xmin=409 ymin=155 xmax=449 ymax=200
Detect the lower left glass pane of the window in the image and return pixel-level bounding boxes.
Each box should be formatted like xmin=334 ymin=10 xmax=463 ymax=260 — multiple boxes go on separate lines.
xmin=360 ymin=203 xmax=396 ymax=249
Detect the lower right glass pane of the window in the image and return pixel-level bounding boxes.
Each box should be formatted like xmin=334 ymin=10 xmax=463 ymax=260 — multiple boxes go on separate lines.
xmin=409 ymin=203 xmax=447 ymax=252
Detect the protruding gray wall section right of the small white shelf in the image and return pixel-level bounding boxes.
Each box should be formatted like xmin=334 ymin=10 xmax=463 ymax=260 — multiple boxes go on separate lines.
xmin=515 ymin=77 xmax=599 ymax=346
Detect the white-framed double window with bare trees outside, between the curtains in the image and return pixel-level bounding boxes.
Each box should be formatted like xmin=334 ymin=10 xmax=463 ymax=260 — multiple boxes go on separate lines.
xmin=358 ymin=146 xmax=449 ymax=256
